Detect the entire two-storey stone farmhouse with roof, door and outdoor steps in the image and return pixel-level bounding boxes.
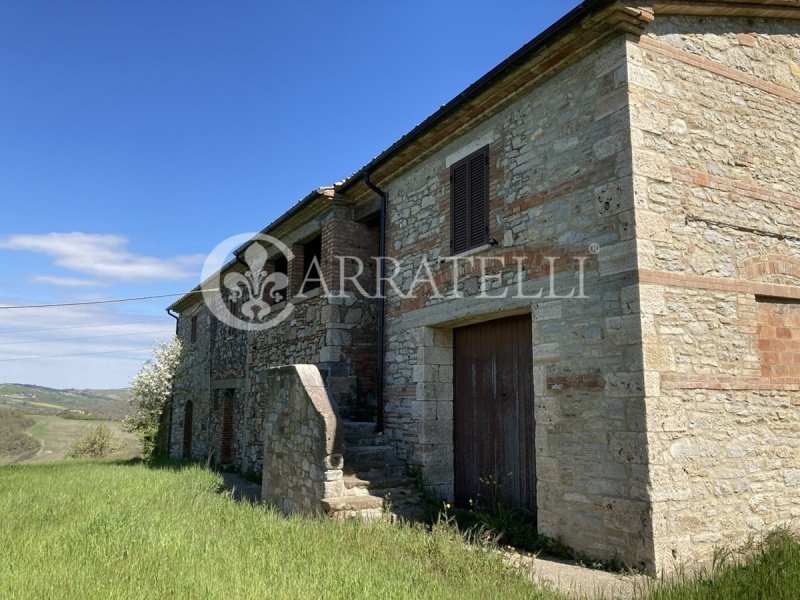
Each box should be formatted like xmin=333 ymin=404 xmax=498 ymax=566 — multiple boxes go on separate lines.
xmin=170 ymin=0 xmax=800 ymax=572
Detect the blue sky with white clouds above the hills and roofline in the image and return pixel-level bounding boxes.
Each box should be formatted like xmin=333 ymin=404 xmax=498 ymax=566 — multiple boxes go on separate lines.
xmin=0 ymin=0 xmax=577 ymax=387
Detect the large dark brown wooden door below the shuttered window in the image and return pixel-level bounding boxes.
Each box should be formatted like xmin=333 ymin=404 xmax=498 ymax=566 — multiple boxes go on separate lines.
xmin=453 ymin=315 xmax=536 ymax=514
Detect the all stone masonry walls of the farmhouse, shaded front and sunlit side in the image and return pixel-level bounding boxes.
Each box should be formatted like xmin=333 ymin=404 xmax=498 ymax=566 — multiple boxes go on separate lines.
xmin=164 ymin=5 xmax=800 ymax=571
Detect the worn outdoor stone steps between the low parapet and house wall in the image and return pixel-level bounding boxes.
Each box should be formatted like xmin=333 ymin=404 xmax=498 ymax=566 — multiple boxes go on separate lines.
xmin=323 ymin=421 xmax=425 ymax=521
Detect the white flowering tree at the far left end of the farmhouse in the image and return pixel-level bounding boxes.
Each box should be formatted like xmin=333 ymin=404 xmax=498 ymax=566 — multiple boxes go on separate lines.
xmin=125 ymin=338 xmax=181 ymax=459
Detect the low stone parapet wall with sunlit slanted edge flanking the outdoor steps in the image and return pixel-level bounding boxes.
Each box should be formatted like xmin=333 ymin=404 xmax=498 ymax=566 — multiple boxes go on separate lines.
xmin=261 ymin=365 xmax=345 ymax=514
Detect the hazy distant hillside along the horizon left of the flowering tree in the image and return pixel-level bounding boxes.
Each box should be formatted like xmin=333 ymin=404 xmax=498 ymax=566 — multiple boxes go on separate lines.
xmin=0 ymin=383 xmax=130 ymax=420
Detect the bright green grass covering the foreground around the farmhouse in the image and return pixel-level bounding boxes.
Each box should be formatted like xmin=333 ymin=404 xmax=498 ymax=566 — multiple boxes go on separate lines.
xmin=0 ymin=461 xmax=800 ymax=600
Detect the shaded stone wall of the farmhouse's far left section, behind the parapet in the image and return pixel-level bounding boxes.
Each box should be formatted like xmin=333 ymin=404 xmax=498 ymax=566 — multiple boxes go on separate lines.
xmin=170 ymin=216 xmax=377 ymax=474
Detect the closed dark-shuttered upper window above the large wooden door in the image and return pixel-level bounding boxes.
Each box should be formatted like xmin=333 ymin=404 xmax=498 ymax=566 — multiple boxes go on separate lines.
xmin=450 ymin=146 xmax=489 ymax=254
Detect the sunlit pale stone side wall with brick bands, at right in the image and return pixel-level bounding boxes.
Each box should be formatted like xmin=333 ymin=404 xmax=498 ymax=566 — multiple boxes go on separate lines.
xmin=628 ymin=16 xmax=800 ymax=568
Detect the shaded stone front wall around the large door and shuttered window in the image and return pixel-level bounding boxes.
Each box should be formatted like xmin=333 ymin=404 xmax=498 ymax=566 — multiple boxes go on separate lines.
xmin=385 ymin=36 xmax=652 ymax=564
